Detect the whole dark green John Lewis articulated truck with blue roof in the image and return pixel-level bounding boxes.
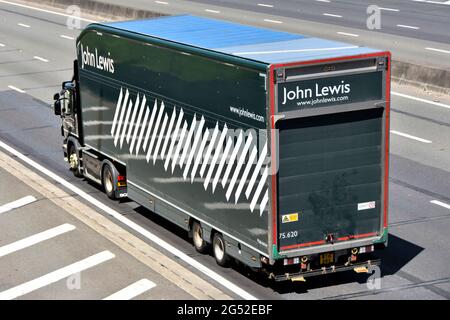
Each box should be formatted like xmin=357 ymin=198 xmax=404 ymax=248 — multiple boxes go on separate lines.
xmin=54 ymin=15 xmax=391 ymax=281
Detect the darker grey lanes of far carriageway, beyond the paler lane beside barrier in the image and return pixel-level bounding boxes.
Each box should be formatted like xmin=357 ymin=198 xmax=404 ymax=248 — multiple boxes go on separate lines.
xmin=189 ymin=0 xmax=450 ymax=43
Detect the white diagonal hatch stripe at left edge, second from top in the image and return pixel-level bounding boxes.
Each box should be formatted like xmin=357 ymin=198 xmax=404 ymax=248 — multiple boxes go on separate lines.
xmin=0 ymin=223 xmax=75 ymax=257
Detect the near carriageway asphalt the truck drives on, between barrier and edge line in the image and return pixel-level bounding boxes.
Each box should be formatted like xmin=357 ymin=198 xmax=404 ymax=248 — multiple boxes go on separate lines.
xmin=0 ymin=0 xmax=450 ymax=299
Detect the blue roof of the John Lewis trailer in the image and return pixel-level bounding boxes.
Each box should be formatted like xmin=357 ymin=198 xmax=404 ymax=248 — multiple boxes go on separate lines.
xmin=104 ymin=15 xmax=379 ymax=64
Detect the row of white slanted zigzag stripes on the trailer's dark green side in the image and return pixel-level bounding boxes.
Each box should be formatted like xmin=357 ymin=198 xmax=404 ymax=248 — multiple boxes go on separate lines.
xmin=111 ymin=88 xmax=269 ymax=216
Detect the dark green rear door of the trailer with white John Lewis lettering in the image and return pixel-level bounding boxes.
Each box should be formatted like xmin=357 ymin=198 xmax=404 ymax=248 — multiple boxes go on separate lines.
xmin=275 ymin=55 xmax=386 ymax=251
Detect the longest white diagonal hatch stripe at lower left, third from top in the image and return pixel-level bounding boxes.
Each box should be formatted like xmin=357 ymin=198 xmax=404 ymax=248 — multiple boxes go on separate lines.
xmin=0 ymin=251 xmax=115 ymax=300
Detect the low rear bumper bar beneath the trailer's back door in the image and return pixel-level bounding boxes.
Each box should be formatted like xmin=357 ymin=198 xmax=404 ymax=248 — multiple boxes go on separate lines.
xmin=269 ymin=259 xmax=381 ymax=281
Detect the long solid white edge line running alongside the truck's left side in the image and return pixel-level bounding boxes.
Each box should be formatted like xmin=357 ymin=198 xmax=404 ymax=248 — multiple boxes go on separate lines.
xmin=0 ymin=138 xmax=257 ymax=300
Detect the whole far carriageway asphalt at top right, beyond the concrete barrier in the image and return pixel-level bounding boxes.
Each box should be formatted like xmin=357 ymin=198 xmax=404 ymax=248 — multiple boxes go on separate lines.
xmin=85 ymin=0 xmax=450 ymax=70
